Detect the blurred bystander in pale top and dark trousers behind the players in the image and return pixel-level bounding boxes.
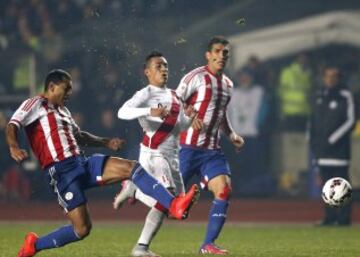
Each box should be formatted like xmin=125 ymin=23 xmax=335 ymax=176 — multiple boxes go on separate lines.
xmin=229 ymin=69 xmax=270 ymax=193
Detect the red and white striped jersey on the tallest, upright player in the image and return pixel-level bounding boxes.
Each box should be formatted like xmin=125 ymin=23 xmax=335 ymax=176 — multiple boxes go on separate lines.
xmin=176 ymin=66 xmax=233 ymax=149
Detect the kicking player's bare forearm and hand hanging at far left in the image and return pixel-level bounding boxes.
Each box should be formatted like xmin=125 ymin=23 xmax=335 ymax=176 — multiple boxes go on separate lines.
xmin=6 ymin=123 xmax=29 ymax=162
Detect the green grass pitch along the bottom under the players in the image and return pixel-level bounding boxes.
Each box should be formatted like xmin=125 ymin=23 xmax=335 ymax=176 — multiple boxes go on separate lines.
xmin=0 ymin=222 xmax=360 ymax=257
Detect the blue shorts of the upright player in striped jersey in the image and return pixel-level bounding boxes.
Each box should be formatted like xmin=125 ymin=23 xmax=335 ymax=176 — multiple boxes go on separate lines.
xmin=179 ymin=146 xmax=231 ymax=188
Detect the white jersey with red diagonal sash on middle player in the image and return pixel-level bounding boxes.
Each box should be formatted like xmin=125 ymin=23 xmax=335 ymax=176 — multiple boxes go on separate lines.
xmin=118 ymin=85 xmax=191 ymax=153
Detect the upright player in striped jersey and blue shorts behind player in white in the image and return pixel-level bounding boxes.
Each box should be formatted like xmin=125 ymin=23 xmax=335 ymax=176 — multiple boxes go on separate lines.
xmin=176 ymin=37 xmax=244 ymax=255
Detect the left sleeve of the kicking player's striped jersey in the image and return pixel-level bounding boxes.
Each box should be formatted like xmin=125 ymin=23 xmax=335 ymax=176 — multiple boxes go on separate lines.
xmin=9 ymin=98 xmax=41 ymax=128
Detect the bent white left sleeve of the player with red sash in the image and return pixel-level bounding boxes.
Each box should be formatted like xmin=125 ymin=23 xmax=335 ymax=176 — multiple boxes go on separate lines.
xmin=118 ymin=88 xmax=151 ymax=120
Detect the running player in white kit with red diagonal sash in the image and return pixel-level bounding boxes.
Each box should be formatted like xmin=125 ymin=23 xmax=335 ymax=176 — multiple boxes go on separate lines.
xmin=114 ymin=52 xmax=200 ymax=257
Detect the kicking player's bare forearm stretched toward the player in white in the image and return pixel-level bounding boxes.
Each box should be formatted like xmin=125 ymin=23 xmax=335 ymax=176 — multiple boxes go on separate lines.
xmin=76 ymin=131 xmax=125 ymax=151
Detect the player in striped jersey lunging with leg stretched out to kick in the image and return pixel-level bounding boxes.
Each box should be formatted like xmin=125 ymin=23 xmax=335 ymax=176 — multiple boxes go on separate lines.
xmin=6 ymin=70 xmax=200 ymax=257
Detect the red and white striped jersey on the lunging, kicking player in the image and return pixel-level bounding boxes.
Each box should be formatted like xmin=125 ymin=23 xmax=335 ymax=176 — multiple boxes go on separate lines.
xmin=9 ymin=96 xmax=80 ymax=168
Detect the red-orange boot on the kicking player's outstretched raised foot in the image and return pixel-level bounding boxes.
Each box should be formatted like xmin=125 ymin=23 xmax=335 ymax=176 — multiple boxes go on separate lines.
xmin=169 ymin=184 xmax=200 ymax=220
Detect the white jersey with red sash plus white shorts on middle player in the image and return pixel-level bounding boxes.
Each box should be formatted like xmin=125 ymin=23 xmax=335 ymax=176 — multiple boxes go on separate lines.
xmin=118 ymin=85 xmax=191 ymax=189
